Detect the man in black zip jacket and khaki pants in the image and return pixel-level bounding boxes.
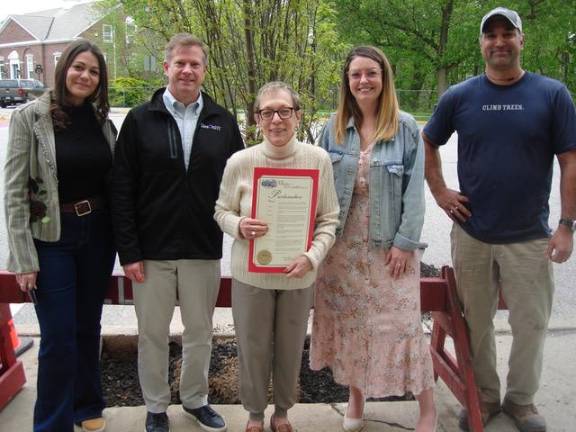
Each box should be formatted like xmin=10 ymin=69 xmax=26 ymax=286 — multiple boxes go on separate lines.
xmin=112 ymin=34 xmax=244 ymax=432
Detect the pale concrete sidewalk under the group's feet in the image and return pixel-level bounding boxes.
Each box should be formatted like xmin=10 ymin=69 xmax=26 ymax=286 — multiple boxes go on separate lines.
xmin=0 ymin=327 xmax=576 ymax=432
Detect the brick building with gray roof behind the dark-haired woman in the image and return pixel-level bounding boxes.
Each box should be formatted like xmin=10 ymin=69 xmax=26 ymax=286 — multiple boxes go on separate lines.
xmin=0 ymin=2 xmax=135 ymax=87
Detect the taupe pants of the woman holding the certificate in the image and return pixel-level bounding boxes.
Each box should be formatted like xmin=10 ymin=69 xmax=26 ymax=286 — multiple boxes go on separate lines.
xmin=232 ymin=279 xmax=313 ymax=420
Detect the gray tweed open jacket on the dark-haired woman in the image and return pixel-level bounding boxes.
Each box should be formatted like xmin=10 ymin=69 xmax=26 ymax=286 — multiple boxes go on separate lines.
xmin=4 ymin=92 xmax=116 ymax=273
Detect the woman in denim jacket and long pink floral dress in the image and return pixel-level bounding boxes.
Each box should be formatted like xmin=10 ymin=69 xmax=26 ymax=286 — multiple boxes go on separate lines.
xmin=310 ymin=47 xmax=436 ymax=432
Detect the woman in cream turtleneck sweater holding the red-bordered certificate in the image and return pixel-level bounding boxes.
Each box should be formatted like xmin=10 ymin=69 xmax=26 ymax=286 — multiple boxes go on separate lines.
xmin=214 ymin=82 xmax=338 ymax=432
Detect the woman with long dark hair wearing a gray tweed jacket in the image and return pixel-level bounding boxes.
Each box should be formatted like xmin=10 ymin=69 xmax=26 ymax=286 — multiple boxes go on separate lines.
xmin=4 ymin=40 xmax=116 ymax=432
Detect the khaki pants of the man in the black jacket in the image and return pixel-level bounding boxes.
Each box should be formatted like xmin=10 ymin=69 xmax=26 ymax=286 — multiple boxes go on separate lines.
xmin=134 ymin=260 xmax=220 ymax=413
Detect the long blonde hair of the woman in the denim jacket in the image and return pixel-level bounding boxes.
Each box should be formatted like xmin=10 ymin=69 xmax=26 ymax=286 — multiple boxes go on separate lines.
xmin=334 ymin=46 xmax=400 ymax=144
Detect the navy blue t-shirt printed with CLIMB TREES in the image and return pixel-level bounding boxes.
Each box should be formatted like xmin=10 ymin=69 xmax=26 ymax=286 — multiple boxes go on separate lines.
xmin=424 ymin=72 xmax=576 ymax=243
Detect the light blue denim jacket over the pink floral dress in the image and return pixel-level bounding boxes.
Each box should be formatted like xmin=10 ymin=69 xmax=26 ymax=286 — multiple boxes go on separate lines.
xmin=319 ymin=112 xmax=427 ymax=250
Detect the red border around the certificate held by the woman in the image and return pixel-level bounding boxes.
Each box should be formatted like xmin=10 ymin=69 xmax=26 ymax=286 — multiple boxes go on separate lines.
xmin=248 ymin=167 xmax=320 ymax=273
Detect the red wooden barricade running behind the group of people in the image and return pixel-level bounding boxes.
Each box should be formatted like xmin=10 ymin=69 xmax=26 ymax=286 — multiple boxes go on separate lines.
xmin=0 ymin=267 xmax=496 ymax=432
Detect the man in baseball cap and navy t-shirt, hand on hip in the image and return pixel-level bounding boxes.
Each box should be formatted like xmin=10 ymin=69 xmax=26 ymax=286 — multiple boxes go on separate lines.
xmin=423 ymin=7 xmax=576 ymax=432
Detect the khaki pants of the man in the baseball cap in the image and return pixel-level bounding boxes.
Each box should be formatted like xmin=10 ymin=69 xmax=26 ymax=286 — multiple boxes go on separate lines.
xmin=451 ymin=224 xmax=554 ymax=405
